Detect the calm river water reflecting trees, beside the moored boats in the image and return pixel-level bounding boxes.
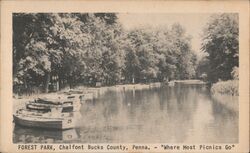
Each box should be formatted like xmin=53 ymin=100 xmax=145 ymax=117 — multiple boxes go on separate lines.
xmin=13 ymin=84 xmax=239 ymax=143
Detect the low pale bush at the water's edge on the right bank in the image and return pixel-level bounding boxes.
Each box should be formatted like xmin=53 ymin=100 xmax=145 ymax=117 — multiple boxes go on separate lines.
xmin=211 ymin=80 xmax=239 ymax=96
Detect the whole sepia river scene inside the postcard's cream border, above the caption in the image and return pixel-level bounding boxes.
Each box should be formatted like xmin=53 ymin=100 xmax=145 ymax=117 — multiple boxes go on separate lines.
xmin=12 ymin=12 xmax=240 ymax=144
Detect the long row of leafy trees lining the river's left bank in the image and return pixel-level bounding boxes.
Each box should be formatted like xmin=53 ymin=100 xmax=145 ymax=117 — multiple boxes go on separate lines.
xmin=13 ymin=13 xmax=197 ymax=92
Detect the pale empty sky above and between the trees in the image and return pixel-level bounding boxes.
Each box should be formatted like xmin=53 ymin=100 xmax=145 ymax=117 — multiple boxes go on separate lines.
xmin=118 ymin=13 xmax=211 ymax=55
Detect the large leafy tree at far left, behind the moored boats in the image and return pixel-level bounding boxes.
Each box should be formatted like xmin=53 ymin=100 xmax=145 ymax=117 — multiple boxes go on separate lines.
xmin=13 ymin=13 xmax=88 ymax=92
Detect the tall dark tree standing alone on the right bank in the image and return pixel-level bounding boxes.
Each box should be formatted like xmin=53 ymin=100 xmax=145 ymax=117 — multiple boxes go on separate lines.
xmin=198 ymin=13 xmax=239 ymax=82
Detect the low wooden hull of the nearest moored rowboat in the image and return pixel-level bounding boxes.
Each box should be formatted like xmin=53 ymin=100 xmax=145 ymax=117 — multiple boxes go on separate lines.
xmin=13 ymin=115 xmax=74 ymax=130
